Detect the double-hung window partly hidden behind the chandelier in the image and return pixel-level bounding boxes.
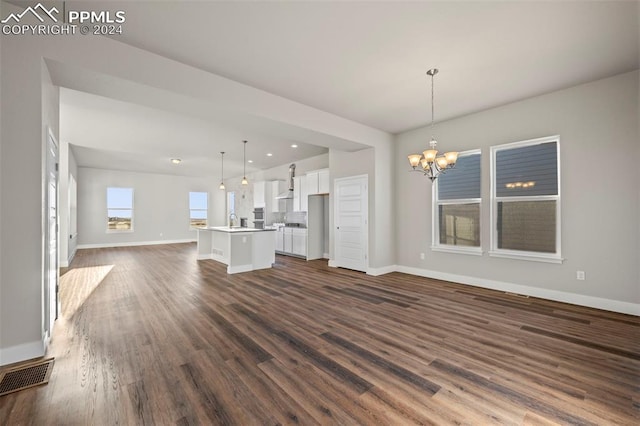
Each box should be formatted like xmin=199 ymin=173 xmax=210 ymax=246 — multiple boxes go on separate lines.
xmin=432 ymin=150 xmax=482 ymax=254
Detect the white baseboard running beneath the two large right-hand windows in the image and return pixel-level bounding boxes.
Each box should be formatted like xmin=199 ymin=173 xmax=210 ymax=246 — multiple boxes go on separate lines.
xmin=396 ymin=266 xmax=640 ymax=316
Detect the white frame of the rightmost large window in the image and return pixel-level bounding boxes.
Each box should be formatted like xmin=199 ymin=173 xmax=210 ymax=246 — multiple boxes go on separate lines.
xmin=489 ymin=135 xmax=564 ymax=263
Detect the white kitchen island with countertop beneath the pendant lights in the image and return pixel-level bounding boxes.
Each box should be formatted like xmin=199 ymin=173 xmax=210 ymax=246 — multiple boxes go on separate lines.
xmin=198 ymin=226 xmax=276 ymax=274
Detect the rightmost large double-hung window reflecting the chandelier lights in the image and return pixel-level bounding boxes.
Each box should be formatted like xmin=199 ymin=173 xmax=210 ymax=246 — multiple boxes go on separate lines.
xmin=490 ymin=136 xmax=562 ymax=263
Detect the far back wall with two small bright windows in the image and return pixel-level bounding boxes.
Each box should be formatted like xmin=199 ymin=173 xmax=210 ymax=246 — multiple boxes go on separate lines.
xmin=78 ymin=167 xmax=225 ymax=248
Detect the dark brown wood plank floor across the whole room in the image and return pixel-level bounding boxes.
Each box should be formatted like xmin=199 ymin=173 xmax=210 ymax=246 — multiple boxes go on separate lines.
xmin=0 ymin=244 xmax=640 ymax=425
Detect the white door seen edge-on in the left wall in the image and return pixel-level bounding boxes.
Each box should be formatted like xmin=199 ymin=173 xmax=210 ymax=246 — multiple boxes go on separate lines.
xmin=43 ymin=133 xmax=58 ymax=338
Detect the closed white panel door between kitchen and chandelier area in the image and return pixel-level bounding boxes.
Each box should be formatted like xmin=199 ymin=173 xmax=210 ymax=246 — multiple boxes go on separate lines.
xmin=333 ymin=175 xmax=369 ymax=272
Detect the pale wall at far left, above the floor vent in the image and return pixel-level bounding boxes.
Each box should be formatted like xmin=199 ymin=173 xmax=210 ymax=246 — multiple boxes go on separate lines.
xmin=0 ymin=40 xmax=59 ymax=365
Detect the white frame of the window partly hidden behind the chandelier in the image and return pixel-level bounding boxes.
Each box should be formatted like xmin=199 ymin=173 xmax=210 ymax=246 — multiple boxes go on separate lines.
xmin=431 ymin=149 xmax=482 ymax=256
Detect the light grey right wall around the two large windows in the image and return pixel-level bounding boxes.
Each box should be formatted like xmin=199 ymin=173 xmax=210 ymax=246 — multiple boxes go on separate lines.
xmin=395 ymin=71 xmax=640 ymax=314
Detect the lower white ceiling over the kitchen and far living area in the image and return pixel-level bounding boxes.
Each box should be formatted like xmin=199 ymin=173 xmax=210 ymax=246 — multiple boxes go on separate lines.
xmin=60 ymin=87 xmax=327 ymax=177
